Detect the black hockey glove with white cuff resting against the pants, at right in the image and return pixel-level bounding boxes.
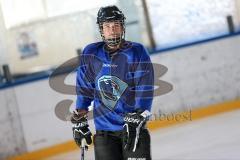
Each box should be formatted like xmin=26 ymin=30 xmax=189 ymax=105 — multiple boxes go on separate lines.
xmin=123 ymin=110 xmax=151 ymax=152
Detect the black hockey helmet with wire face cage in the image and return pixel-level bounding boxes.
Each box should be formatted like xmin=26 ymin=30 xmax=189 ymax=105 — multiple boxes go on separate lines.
xmin=97 ymin=5 xmax=126 ymax=47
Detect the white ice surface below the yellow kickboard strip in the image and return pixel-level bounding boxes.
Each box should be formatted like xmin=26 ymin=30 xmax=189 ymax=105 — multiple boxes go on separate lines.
xmin=45 ymin=110 xmax=240 ymax=160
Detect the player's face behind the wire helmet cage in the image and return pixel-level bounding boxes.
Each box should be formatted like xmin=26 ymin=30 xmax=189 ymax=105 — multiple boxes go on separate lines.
xmin=103 ymin=21 xmax=123 ymax=39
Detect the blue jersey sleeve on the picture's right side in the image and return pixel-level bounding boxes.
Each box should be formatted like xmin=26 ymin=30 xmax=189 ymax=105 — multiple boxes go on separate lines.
xmin=134 ymin=46 xmax=154 ymax=111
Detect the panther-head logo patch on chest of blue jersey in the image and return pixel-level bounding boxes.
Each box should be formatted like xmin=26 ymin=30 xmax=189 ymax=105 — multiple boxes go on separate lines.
xmin=98 ymin=75 xmax=128 ymax=110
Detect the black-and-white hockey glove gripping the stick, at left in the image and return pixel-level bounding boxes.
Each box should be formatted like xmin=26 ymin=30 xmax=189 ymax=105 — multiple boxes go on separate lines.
xmin=71 ymin=112 xmax=92 ymax=147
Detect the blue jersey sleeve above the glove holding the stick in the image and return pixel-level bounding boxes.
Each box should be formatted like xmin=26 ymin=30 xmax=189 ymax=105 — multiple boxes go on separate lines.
xmin=76 ymin=51 xmax=95 ymax=110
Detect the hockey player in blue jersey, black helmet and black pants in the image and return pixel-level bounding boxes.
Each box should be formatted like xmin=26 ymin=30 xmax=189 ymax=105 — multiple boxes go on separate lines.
xmin=71 ymin=6 xmax=154 ymax=160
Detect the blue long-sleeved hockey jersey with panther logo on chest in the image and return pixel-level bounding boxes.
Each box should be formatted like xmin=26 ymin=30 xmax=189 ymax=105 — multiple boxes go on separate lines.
xmin=76 ymin=41 xmax=154 ymax=131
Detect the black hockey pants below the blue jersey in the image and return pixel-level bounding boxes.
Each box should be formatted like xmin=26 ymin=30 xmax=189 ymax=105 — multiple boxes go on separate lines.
xmin=93 ymin=129 xmax=151 ymax=160
